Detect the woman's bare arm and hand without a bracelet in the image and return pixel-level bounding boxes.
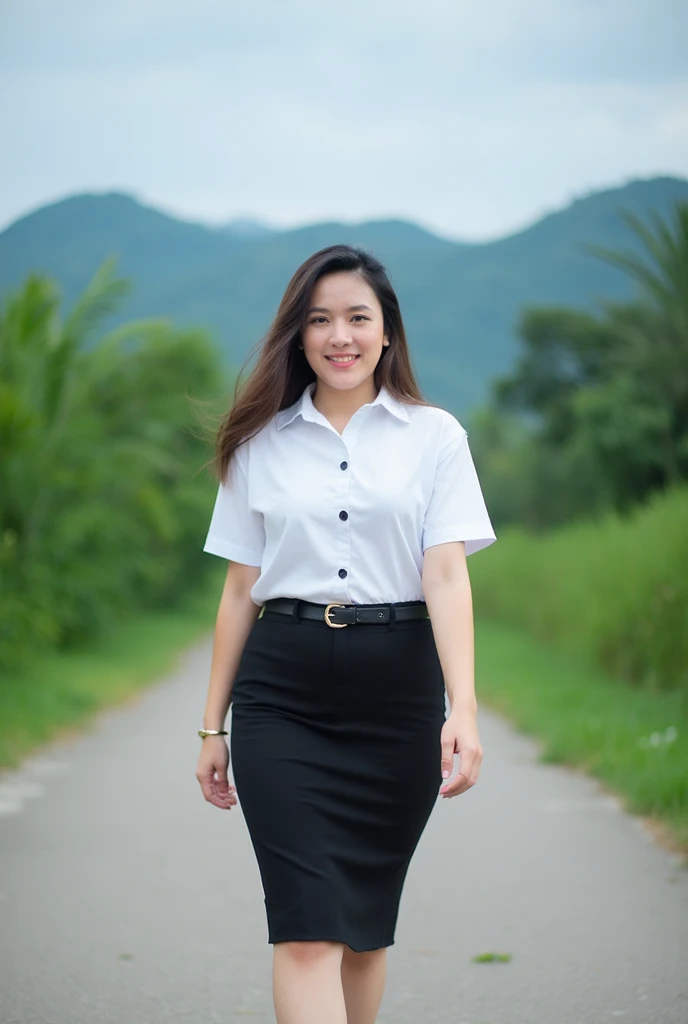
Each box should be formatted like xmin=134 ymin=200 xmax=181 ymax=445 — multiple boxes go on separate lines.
xmin=422 ymin=541 xmax=483 ymax=799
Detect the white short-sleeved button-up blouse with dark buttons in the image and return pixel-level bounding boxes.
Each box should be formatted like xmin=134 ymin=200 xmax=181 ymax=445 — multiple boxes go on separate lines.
xmin=203 ymin=381 xmax=496 ymax=605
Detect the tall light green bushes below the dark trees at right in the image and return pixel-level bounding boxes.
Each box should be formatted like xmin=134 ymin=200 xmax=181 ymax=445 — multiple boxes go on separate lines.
xmin=471 ymin=486 xmax=688 ymax=693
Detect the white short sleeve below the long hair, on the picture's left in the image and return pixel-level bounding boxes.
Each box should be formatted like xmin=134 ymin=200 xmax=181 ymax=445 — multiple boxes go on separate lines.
xmin=203 ymin=443 xmax=265 ymax=565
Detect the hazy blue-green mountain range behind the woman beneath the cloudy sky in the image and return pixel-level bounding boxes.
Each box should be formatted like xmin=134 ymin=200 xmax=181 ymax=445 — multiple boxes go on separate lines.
xmin=0 ymin=177 xmax=688 ymax=418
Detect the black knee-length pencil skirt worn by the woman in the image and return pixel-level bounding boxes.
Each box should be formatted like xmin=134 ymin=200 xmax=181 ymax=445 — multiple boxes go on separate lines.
xmin=230 ymin=602 xmax=445 ymax=952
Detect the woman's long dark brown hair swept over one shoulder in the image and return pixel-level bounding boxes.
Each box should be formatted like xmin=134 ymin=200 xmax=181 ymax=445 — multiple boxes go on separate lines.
xmin=213 ymin=245 xmax=428 ymax=481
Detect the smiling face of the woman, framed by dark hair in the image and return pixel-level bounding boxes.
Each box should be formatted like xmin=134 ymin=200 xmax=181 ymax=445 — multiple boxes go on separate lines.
xmin=302 ymin=270 xmax=389 ymax=390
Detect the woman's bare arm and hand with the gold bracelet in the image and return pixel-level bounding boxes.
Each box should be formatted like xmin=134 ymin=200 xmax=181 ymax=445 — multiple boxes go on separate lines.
xmin=196 ymin=562 xmax=260 ymax=810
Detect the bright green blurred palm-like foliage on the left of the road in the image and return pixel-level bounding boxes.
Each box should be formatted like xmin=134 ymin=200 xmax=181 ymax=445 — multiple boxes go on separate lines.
xmin=0 ymin=261 xmax=225 ymax=668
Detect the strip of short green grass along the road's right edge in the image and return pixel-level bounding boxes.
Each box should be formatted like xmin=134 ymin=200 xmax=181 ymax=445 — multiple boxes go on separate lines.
xmin=476 ymin=621 xmax=688 ymax=865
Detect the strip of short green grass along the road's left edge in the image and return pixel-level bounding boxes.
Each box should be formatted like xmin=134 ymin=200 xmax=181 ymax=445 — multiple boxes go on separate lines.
xmin=0 ymin=566 xmax=226 ymax=768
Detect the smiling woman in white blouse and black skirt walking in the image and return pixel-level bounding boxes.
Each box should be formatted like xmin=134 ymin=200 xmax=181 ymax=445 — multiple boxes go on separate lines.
xmin=197 ymin=245 xmax=495 ymax=1024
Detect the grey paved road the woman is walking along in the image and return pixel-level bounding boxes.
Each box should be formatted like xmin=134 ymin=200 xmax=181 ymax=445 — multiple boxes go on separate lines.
xmin=0 ymin=641 xmax=688 ymax=1024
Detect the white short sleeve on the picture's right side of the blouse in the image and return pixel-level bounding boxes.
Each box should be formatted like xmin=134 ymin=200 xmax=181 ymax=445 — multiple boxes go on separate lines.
xmin=422 ymin=416 xmax=497 ymax=555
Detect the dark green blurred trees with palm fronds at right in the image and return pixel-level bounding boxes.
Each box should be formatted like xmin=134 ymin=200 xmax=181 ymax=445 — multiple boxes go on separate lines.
xmin=471 ymin=202 xmax=688 ymax=529
